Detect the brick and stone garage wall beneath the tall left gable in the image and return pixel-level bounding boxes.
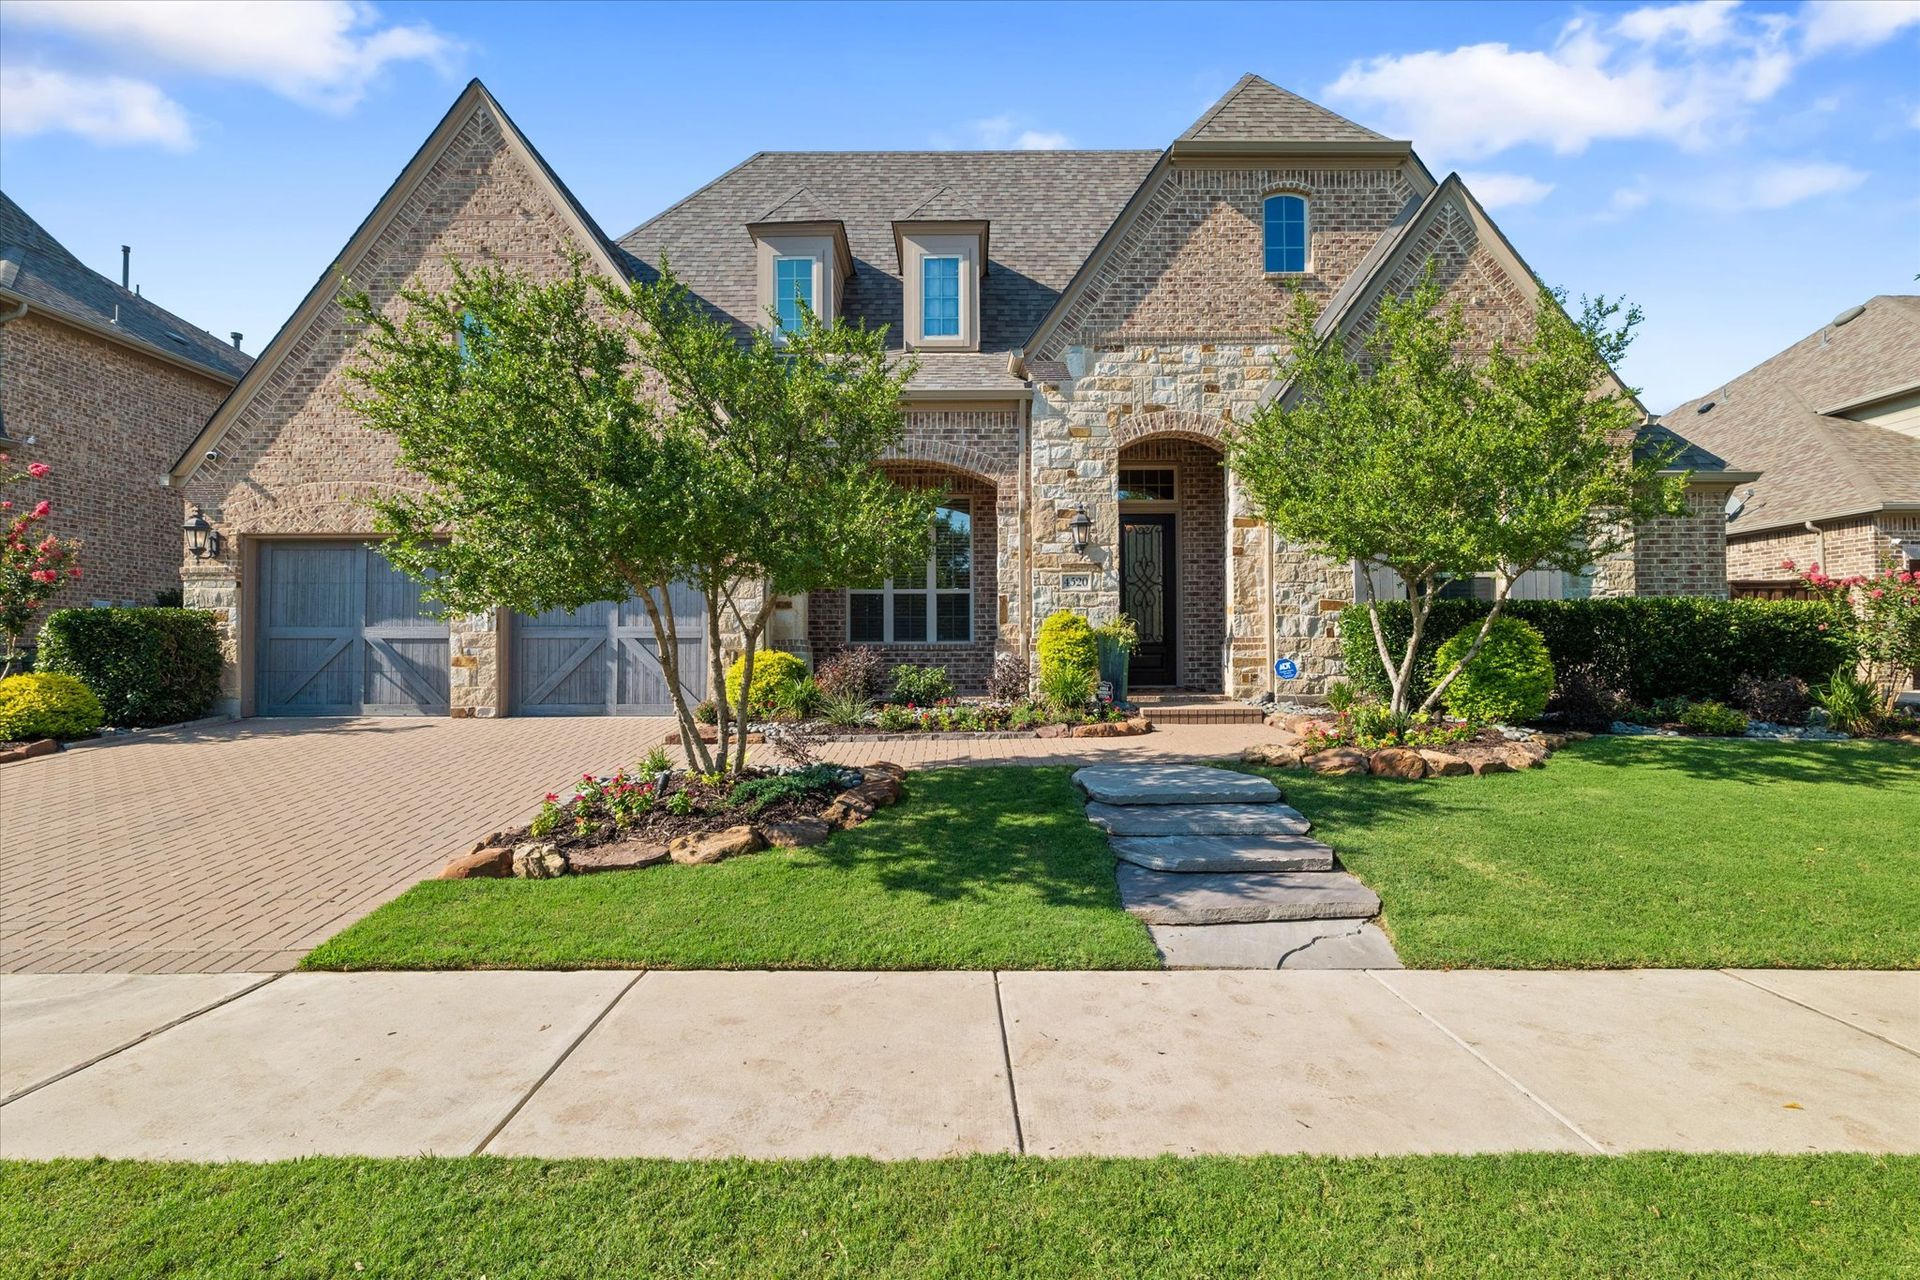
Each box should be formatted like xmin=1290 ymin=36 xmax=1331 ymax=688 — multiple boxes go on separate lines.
xmin=169 ymin=107 xmax=602 ymax=716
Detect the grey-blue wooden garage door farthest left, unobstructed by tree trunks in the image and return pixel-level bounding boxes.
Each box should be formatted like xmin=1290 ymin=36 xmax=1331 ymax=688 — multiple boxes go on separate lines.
xmin=253 ymin=543 xmax=447 ymax=716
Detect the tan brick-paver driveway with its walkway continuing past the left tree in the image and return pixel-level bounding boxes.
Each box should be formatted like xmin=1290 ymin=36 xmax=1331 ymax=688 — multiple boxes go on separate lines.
xmin=0 ymin=718 xmax=1263 ymax=973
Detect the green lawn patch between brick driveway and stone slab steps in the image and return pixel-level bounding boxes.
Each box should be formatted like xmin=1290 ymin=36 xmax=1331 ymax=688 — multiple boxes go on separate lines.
xmin=305 ymin=768 xmax=1160 ymax=969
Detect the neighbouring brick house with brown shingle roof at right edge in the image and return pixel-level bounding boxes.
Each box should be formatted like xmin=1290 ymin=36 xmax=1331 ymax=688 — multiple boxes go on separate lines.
xmin=1661 ymin=294 xmax=1920 ymax=595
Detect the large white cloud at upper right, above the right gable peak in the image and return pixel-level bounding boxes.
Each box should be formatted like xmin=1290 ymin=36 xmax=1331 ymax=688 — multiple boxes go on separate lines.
xmin=1327 ymin=0 xmax=1812 ymax=159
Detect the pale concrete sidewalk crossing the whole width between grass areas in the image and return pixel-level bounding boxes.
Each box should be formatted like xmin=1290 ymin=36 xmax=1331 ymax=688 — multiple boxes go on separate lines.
xmin=0 ymin=969 xmax=1920 ymax=1159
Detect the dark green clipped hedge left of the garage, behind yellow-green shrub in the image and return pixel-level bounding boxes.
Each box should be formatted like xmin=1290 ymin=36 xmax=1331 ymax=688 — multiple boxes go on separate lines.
xmin=36 ymin=608 xmax=221 ymax=725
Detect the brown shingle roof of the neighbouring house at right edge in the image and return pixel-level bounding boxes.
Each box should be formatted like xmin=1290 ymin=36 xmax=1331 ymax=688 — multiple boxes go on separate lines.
xmin=1661 ymin=294 xmax=1920 ymax=533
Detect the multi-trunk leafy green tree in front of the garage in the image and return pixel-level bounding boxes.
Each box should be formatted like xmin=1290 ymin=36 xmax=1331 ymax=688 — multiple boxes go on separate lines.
xmin=344 ymin=263 xmax=933 ymax=771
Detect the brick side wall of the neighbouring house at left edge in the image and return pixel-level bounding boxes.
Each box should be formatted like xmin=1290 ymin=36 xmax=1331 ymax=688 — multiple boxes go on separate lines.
xmin=0 ymin=311 xmax=230 ymax=629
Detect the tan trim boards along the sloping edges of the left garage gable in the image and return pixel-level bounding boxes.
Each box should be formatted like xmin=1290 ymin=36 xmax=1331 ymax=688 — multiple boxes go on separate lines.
xmin=171 ymin=81 xmax=630 ymax=484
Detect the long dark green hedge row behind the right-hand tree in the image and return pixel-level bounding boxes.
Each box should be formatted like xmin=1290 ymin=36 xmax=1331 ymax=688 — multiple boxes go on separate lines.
xmin=1340 ymin=597 xmax=1859 ymax=704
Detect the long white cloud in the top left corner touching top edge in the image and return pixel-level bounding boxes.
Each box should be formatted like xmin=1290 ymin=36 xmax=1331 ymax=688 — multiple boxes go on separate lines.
xmin=6 ymin=0 xmax=455 ymax=111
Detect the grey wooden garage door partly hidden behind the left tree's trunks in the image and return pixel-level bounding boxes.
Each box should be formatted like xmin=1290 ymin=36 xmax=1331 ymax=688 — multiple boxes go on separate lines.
xmin=513 ymin=583 xmax=707 ymax=716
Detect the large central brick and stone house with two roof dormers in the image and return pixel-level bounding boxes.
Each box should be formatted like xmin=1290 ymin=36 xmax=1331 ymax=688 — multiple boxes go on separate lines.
xmin=173 ymin=77 xmax=1741 ymax=716
